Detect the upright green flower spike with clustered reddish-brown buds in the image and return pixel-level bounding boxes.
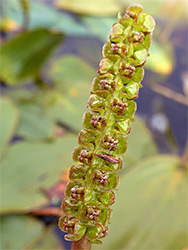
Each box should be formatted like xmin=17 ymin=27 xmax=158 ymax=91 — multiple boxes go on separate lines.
xmin=59 ymin=5 xmax=155 ymax=243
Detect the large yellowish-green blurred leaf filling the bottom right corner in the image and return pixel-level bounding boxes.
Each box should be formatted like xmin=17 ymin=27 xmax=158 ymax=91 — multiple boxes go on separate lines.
xmin=95 ymin=155 xmax=188 ymax=250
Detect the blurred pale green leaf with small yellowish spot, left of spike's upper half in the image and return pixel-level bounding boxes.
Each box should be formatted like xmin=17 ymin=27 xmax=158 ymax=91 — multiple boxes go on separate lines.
xmin=49 ymin=56 xmax=96 ymax=129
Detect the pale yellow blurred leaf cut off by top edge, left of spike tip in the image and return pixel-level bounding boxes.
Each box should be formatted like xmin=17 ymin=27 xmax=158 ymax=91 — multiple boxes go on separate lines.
xmin=55 ymin=0 xmax=121 ymax=16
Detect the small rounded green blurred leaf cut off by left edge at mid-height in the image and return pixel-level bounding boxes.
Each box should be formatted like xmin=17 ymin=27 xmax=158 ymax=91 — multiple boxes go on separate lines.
xmin=0 ymin=97 xmax=19 ymax=151
